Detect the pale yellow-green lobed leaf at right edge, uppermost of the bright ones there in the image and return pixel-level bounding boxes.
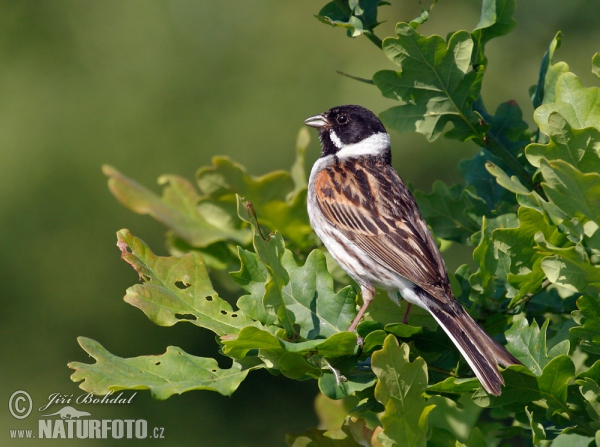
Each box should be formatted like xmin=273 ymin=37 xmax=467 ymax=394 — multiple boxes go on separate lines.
xmin=533 ymin=73 xmax=600 ymax=134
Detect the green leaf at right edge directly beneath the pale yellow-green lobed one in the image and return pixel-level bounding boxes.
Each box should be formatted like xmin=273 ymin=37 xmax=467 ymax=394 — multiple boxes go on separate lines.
xmin=525 ymin=113 xmax=600 ymax=173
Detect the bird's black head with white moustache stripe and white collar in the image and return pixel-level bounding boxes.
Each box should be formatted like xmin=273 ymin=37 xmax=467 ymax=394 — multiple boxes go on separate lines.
xmin=304 ymin=105 xmax=391 ymax=162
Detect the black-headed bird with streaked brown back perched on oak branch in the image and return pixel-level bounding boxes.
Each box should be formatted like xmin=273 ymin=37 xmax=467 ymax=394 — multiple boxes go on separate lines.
xmin=304 ymin=105 xmax=521 ymax=396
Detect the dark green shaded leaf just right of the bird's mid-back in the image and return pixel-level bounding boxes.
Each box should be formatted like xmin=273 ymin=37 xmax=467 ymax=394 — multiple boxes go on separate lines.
xmin=415 ymin=180 xmax=488 ymax=243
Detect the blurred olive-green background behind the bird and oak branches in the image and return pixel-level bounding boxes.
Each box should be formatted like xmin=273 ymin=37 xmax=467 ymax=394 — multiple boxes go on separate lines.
xmin=0 ymin=0 xmax=600 ymax=446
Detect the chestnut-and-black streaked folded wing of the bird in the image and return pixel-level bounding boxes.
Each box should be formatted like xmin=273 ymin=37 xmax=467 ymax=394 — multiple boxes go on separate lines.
xmin=314 ymin=160 xmax=452 ymax=302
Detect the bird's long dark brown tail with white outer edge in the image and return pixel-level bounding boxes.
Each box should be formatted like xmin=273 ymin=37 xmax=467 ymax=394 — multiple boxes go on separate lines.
xmin=427 ymin=300 xmax=521 ymax=396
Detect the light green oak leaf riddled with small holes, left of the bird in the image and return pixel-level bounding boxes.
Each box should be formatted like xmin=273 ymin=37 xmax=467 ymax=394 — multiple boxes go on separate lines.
xmin=117 ymin=230 xmax=251 ymax=335
